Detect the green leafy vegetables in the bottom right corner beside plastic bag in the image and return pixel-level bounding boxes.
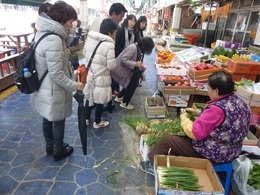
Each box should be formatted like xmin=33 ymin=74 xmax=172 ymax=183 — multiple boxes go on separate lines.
xmin=247 ymin=162 xmax=260 ymax=190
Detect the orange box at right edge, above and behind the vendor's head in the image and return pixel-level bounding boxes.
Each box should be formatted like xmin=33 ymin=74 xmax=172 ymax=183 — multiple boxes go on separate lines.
xmin=226 ymin=59 xmax=260 ymax=75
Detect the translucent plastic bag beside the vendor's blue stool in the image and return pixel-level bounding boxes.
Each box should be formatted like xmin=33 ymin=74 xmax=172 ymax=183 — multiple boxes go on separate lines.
xmin=231 ymin=155 xmax=260 ymax=195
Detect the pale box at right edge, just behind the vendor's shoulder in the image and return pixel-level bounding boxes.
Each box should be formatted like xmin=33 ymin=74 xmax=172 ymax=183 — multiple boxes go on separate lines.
xmin=236 ymin=86 xmax=260 ymax=107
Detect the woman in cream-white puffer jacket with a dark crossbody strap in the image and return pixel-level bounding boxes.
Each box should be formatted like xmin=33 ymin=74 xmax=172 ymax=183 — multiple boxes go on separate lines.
xmin=83 ymin=19 xmax=118 ymax=129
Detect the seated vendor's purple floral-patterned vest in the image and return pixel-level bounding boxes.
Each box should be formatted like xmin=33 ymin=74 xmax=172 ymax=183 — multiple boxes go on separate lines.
xmin=193 ymin=95 xmax=250 ymax=163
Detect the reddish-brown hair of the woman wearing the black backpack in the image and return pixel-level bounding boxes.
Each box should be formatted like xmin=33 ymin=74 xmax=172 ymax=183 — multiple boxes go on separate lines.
xmin=47 ymin=1 xmax=78 ymax=24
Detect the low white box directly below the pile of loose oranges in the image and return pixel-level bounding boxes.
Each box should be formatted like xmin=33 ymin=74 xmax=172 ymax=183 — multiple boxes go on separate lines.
xmin=156 ymin=64 xmax=188 ymax=76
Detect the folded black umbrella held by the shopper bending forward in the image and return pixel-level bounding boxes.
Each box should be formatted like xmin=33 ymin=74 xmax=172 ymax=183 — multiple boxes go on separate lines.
xmin=123 ymin=53 xmax=145 ymax=106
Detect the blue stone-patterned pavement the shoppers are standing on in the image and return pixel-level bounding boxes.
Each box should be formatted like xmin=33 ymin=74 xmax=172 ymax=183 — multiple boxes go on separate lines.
xmin=0 ymin=49 xmax=170 ymax=195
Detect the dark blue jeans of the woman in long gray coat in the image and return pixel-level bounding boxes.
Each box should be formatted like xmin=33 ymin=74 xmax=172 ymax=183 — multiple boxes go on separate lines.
xmin=42 ymin=118 xmax=65 ymax=154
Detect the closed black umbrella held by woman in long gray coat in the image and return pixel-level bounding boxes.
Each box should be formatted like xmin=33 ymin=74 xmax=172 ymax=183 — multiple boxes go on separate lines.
xmin=74 ymin=74 xmax=87 ymax=162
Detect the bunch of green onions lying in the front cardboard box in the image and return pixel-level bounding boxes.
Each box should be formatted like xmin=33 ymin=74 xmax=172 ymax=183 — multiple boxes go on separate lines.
xmin=157 ymin=166 xmax=202 ymax=191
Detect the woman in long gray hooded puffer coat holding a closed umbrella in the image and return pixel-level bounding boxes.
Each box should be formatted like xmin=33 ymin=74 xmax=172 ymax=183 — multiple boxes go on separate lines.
xmin=32 ymin=1 xmax=84 ymax=161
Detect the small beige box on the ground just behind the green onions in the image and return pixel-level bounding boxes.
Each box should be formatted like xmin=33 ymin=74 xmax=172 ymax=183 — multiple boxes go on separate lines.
xmin=145 ymin=97 xmax=166 ymax=118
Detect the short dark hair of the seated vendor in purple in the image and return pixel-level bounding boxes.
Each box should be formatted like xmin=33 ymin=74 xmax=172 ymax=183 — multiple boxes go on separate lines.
xmin=208 ymin=71 xmax=235 ymax=95
